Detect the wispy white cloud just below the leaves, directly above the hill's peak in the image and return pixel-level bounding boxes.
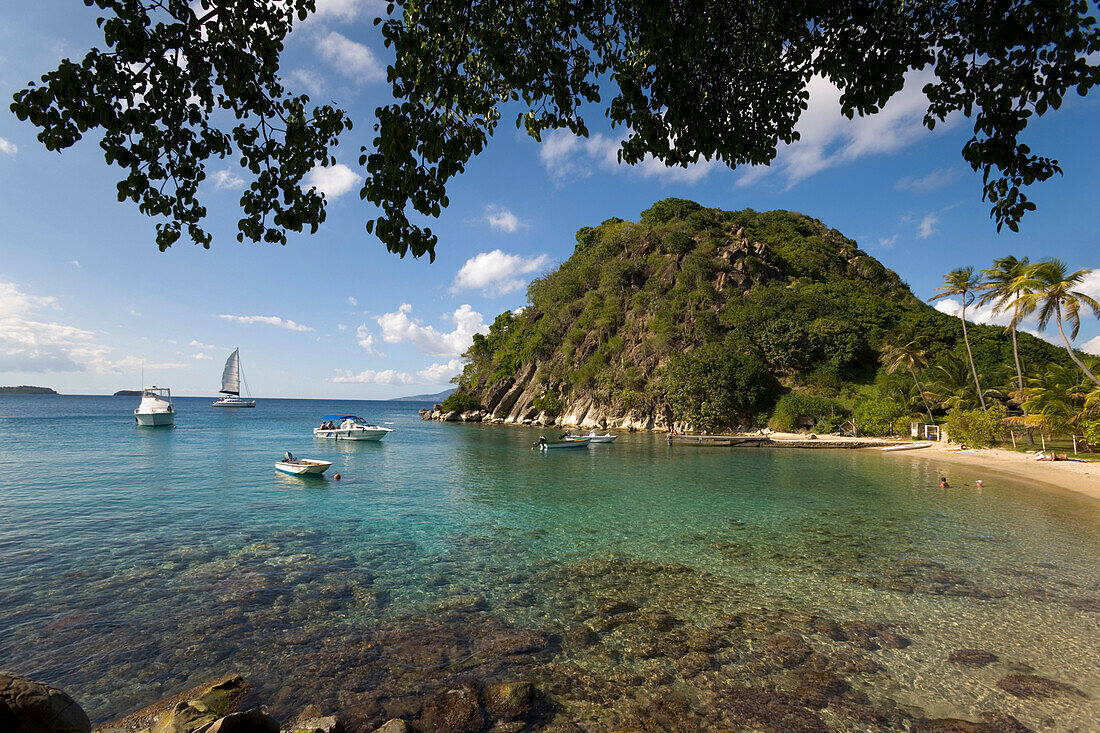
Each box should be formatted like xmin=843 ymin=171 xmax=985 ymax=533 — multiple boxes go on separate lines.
xmin=539 ymin=130 xmax=722 ymax=185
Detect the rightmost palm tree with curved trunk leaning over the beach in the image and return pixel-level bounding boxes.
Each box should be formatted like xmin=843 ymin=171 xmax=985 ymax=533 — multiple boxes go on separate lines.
xmin=1010 ymin=259 xmax=1100 ymax=385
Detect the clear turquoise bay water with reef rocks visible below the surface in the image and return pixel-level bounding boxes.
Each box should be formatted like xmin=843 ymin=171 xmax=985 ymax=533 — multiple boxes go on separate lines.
xmin=0 ymin=396 xmax=1100 ymax=731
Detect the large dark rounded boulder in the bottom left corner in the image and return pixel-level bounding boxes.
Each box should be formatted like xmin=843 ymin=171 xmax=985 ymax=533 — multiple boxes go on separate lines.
xmin=0 ymin=671 xmax=91 ymax=733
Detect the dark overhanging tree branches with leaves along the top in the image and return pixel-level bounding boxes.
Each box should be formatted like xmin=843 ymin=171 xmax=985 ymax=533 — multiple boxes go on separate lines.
xmin=12 ymin=0 xmax=1100 ymax=256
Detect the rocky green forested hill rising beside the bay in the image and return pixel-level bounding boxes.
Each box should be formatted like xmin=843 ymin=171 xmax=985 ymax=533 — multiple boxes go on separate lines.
xmin=449 ymin=199 xmax=1058 ymax=429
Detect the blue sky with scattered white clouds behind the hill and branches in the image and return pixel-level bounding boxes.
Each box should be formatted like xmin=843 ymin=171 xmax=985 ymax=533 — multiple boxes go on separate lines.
xmin=0 ymin=0 xmax=1100 ymax=400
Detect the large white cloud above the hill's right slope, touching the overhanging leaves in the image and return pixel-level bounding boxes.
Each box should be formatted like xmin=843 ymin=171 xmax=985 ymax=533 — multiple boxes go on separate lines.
xmin=737 ymin=70 xmax=959 ymax=188
